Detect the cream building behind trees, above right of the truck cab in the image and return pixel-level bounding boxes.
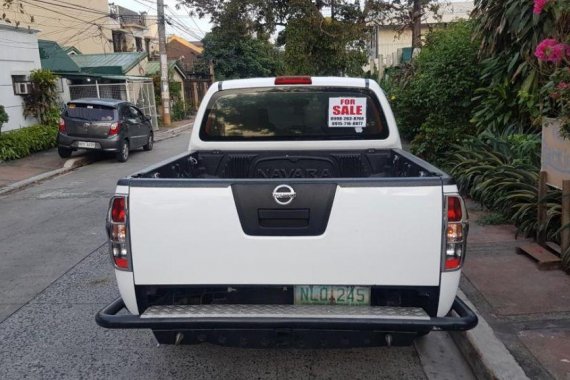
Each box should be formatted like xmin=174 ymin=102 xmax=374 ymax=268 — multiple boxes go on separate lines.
xmin=368 ymin=1 xmax=474 ymax=67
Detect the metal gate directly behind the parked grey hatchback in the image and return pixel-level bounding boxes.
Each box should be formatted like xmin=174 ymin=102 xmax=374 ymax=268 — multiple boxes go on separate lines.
xmin=69 ymin=80 xmax=158 ymax=130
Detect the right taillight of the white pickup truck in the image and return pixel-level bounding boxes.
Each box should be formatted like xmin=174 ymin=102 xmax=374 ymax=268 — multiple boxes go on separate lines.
xmin=443 ymin=195 xmax=469 ymax=271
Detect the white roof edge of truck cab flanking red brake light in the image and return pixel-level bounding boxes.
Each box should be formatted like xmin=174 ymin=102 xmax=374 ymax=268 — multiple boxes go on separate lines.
xmin=212 ymin=77 xmax=367 ymax=90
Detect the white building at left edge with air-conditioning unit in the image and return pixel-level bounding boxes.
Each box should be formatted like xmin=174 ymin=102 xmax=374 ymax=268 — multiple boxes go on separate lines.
xmin=0 ymin=24 xmax=41 ymax=132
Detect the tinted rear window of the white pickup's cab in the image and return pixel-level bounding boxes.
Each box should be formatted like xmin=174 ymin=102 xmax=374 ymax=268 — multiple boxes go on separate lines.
xmin=200 ymin=87 xmax=388 ymax=141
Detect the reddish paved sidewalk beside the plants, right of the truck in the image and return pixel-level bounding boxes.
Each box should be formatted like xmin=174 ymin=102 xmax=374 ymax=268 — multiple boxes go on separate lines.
xmin=461 ymin=202 xmax=570 ymax=379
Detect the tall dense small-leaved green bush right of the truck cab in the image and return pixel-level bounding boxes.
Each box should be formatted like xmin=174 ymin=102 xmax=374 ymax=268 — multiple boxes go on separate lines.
xmin=389 ymin=21 xmax=480 ymax=163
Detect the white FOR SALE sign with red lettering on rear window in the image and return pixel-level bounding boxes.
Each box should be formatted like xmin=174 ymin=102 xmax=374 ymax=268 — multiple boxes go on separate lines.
xmin=329 ymin=98 xmax=366 ymax=132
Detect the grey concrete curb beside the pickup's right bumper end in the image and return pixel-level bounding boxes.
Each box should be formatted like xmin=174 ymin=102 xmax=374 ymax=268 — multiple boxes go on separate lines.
xmin=450 ymin=290 xmax=528 ymax=380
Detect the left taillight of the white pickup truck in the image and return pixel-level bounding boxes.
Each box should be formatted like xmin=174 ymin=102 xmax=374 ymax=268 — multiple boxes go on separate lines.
xmin=107 ymin=195 xmax=130 ymax=270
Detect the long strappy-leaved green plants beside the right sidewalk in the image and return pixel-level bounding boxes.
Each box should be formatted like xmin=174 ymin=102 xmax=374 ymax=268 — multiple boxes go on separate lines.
xmin=447 ymin=130 xmax=561 ymax=241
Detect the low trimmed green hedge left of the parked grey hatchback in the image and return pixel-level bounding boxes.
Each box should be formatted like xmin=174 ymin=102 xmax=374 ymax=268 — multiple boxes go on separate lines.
xmin=0 ymin=125 xmax=57 ymax=161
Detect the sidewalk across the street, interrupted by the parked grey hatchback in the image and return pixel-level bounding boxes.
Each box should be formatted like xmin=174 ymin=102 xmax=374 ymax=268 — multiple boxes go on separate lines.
xmin=0 ymin=118 xmax=194 ymax=194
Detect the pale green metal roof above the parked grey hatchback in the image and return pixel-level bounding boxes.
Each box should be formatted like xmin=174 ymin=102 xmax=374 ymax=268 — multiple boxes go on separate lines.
xmin=71 ymin=52 xmax=146 ymax=75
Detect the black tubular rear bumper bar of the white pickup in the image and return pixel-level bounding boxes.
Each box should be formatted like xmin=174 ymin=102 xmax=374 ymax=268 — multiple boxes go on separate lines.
xmin=95 ymin=297 xmax=478 ymax=333
